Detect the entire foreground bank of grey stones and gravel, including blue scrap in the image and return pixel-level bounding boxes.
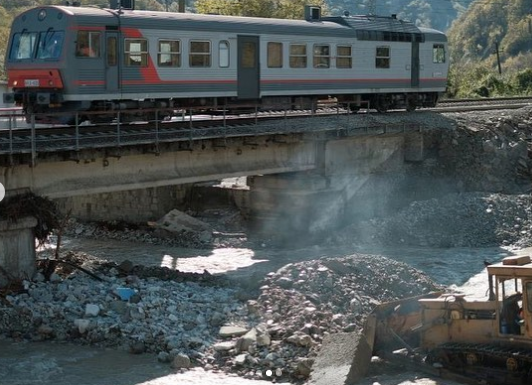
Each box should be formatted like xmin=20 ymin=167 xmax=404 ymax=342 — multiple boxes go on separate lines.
xmin=0 ymin=255 xmax=437 ymax=380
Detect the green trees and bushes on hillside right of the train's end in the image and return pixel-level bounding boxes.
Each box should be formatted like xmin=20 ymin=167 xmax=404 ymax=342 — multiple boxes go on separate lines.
xmin=447 ymin=0 xmax=532 ymax=97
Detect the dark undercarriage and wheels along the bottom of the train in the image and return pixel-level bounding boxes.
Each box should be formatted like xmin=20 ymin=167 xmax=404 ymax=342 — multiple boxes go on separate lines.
xmin=12 ymin=90 xmax=438 ymax=124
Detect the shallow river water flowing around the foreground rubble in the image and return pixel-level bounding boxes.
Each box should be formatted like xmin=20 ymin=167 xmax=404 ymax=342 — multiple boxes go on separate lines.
xmin=0 ymin=239 xmax=527 ymax=385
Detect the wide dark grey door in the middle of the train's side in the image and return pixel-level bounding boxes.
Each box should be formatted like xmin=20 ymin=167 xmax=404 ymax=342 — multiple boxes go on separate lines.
xmin=237 ymin=35 xmax=260 ymax=99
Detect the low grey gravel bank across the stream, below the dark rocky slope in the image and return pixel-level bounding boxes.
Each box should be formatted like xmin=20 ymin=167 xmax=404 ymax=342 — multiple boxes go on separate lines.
xmin=338 ymin=192 xmax=532 ymax=247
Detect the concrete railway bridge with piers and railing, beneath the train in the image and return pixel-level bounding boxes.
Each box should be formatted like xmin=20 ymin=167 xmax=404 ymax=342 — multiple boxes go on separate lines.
xmin=0 ymin=108 xmax=423 ymax=286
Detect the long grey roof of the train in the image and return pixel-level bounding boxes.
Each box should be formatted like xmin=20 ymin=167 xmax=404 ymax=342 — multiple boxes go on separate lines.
xmin=11 ymin=6 xmax=445 ymax=40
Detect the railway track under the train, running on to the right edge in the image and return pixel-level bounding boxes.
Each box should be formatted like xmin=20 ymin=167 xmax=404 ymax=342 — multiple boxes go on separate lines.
xmin=0 ymin=97 xmax=532 ymax=155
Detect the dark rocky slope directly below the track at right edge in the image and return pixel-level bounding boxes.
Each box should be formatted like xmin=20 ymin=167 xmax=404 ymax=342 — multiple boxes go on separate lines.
xmin=434 ymin=107 xmax=532 ymax=194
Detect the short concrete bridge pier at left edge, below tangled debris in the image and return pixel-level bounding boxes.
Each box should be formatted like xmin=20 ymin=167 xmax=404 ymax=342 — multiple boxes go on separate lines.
xmin=0 ymin=217 xmax=37 ymax=287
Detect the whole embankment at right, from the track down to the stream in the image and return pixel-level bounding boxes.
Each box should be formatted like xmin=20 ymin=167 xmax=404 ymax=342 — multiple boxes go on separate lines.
xmin=328 ymin=107 xmax=532 ymax=247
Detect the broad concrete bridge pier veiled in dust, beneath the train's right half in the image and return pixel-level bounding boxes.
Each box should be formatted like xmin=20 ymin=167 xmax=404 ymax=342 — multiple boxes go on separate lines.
xmin=248 ymin=135 xmax=408 ymax=241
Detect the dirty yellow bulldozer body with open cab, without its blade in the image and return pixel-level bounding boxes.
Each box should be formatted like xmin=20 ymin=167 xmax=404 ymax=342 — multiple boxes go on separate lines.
xmin=364 ymin=256 xmax=532 ymax=385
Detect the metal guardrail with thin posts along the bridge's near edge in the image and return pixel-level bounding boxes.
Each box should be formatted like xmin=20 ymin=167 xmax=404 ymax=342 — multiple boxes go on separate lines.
xmin=0 ymin=103 xmax=422 ymax=163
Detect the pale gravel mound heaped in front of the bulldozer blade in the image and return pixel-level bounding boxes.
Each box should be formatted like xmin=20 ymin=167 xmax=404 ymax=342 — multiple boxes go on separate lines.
xmin=208 ymin=255 xmax=441 ymax=379
